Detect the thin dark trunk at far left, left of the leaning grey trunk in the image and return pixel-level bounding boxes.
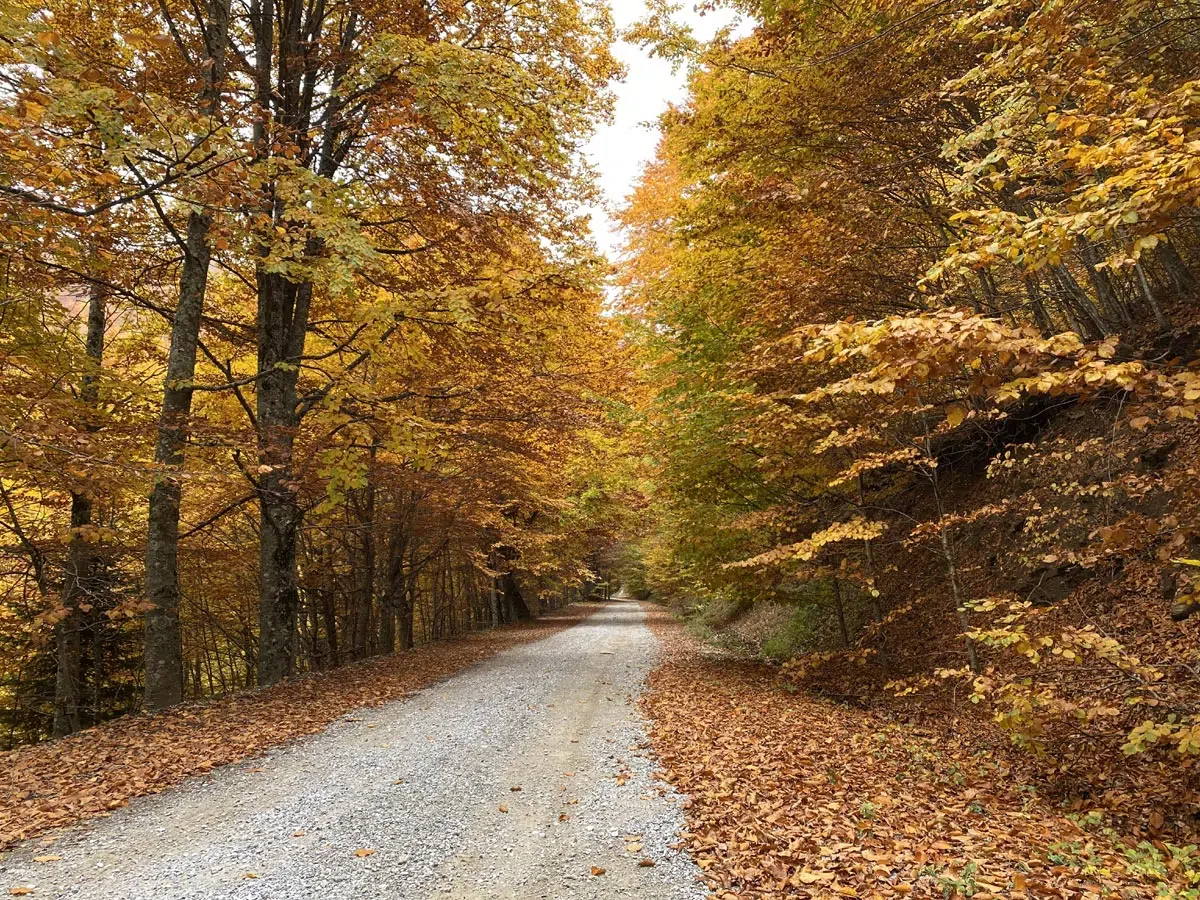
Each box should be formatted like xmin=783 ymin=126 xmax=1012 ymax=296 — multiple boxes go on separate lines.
xmin=53 ymin=283 xmax=108 ymax=737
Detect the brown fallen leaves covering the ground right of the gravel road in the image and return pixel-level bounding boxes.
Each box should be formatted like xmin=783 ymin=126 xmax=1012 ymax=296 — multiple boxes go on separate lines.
xmin=642 ymin=611 xmax=1198 ymax=900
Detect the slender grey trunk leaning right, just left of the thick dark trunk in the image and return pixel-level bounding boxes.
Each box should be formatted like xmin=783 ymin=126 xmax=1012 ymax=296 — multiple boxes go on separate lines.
xmin=144 ymin=0 xmax=229 ymax=709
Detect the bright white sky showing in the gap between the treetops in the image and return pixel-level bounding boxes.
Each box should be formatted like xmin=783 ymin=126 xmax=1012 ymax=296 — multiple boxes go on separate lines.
xmin=587 ymin=0 xmax=733 ymax=259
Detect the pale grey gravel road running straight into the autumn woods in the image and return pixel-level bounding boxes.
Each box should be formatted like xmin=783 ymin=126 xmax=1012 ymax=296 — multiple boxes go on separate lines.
xmin=0 ymin=602 xmax=706 ymax=900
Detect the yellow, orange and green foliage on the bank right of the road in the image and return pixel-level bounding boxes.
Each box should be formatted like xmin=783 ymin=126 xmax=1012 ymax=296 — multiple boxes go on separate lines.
xmin=622 ymin=0 xmax=1200 ymax=842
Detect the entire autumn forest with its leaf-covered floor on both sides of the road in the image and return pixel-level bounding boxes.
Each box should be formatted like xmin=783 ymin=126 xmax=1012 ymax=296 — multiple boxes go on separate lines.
xmin=0 ymin=0 xmax=1200 ymax=898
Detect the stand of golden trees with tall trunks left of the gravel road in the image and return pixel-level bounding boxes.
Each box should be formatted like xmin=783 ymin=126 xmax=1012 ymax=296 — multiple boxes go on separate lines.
xmin=0 ymin=0 xmax=633 ymax=745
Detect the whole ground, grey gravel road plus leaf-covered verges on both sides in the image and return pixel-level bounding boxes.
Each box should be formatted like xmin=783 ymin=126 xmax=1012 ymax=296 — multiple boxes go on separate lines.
xmin=0 ymin=602 xmax=1200 ymax=900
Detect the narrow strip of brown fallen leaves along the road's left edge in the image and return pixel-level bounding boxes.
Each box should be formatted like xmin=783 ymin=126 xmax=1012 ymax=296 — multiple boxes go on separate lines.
xmin=0 ymin=604 xmax=600 ymax=850
